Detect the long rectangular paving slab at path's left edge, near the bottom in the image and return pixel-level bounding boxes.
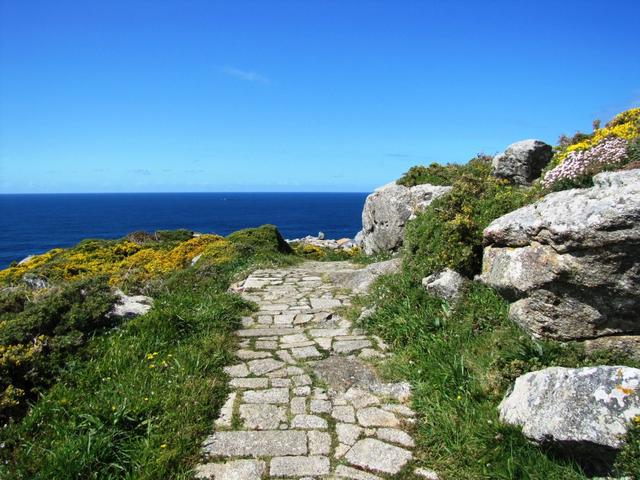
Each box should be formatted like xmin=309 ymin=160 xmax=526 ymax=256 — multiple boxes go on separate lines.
xmin=204 ymin=430 xmax=307 ymax=457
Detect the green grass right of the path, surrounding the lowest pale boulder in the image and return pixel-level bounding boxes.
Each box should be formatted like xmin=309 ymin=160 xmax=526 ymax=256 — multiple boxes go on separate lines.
xmin=353 ymin=273 xmax=638 ymax=480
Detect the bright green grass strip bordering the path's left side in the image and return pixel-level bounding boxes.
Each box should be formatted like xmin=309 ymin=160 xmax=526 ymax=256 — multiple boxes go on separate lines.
xmin=0 ymin=239 xmax=299 ymax=480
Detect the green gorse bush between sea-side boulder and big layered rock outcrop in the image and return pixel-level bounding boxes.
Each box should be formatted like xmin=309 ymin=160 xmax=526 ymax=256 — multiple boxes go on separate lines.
xmin=403 ymin=158 xmax=536 ymax=278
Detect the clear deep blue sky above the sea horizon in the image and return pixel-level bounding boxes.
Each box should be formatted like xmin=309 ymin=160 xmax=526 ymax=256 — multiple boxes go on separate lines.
xmin=0 ymin=0 xmax=640 ymax=193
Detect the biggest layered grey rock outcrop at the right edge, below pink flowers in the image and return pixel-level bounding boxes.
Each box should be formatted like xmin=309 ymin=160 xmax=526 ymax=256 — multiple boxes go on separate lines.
xmin=480 ymin=170 xmax=640 ymax=340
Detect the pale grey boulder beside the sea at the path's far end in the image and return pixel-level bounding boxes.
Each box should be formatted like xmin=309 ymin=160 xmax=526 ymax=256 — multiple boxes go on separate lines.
xmin=357 ymin=183 xmax=451 ymax=255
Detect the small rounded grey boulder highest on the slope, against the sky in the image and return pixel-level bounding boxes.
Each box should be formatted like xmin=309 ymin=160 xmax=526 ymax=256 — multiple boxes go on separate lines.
xmin=493 ymin=140 xmax=553 ymax=185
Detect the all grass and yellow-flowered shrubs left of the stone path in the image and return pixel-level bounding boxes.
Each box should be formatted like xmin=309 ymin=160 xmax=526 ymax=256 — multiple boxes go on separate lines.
xmin=0 ymin=226 xmax=299 ymax=479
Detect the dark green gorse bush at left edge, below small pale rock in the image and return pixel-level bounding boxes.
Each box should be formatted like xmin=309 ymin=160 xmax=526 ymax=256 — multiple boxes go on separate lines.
xmin=0 ymin=277 xmax=115 ymax=421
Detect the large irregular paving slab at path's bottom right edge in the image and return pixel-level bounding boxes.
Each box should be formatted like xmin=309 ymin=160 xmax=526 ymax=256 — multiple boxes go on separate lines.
xmin=345 ymin=438 xmax=412 ymax=474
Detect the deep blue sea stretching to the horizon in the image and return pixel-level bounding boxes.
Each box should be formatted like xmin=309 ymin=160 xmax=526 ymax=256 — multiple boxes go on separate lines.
xmin=0 ymin=193 xmax=367 ymax=268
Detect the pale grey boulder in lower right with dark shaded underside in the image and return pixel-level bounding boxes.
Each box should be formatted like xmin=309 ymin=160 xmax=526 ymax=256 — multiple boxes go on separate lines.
xmin=498 ymin=366 xmax=640 ymax=473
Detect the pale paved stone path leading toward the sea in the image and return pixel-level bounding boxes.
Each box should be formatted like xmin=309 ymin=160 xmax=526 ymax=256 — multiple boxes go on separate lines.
xmin=197 ymin=262 xmax=415 ymax=480
